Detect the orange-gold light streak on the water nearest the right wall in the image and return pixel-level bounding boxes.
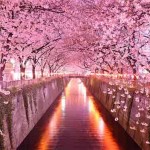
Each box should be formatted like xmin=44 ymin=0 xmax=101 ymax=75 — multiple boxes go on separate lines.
xmin=88 ymin=96 xmax=119 ymax=150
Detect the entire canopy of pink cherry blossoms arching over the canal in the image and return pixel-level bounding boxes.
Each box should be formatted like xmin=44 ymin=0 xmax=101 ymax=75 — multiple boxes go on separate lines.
xmin=0 ymin=0 xmax=150 ymax=80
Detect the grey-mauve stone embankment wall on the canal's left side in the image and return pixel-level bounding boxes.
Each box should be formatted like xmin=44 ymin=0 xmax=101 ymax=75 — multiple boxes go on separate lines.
xmin=0 ymin=77 xmax=69 ymax=150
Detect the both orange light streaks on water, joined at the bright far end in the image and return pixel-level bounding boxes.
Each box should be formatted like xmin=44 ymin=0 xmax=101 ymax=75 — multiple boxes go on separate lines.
xmin=36 ymin=79 xmax=125 ymax=150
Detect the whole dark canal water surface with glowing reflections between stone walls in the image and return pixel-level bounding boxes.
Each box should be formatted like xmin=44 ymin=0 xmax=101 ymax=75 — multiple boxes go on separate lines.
xmin=18 ymin=79 xmax=140 ymax=150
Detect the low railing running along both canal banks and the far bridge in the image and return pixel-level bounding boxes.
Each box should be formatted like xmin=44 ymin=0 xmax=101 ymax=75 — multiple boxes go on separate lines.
xmin=0 ymin=74 xmax=150 ymax=89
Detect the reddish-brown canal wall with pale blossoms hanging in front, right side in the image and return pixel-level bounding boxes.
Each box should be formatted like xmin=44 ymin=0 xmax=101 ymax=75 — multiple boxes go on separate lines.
xmin=84 ymin=77 xmax=150 ymax=150
